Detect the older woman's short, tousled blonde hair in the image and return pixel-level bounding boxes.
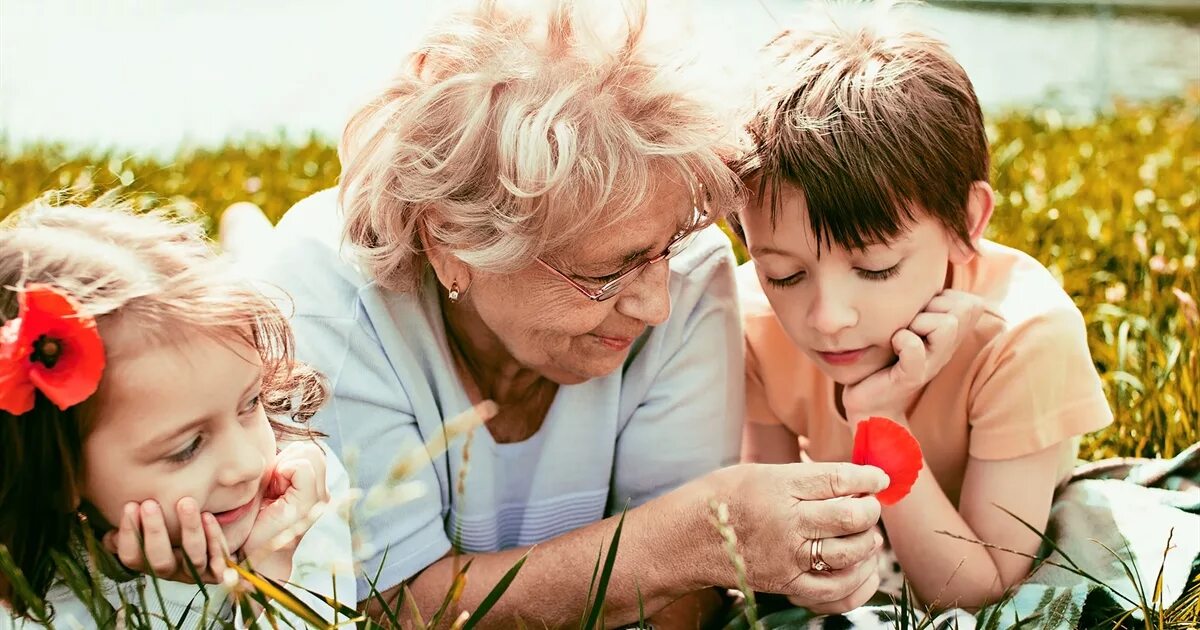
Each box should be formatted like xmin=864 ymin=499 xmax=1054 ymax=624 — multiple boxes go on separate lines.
xmin=340 ymin=0 xmax=742 ymax=290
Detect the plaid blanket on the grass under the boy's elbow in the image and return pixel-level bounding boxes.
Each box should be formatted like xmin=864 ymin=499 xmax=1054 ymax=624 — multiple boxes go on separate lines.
xmin=728 ymin=444 xmax=1200 ymax=630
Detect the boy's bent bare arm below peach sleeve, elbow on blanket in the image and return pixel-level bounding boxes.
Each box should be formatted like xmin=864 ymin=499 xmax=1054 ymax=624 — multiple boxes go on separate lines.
xmin=883 ymin=440 xmax=1072 ymax=608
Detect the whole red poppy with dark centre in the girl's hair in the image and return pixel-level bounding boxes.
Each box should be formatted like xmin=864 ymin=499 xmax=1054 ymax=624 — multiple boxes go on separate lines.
xmin=0 ymin=284 xmax=104 ymax=415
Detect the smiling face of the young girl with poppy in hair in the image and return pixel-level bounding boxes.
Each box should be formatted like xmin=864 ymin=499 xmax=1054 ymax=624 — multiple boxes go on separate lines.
xmin=82 ymin=326 xmax=276 ymax=550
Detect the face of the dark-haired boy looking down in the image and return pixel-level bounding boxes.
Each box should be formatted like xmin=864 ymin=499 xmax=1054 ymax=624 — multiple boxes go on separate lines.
xmin=742 ymin=187 xmax=955 ymax=385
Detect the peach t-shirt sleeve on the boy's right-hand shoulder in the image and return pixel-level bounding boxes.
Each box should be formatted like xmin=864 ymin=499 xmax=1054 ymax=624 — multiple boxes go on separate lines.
xmin=968 ymin=307 xmax=1112 ymax=460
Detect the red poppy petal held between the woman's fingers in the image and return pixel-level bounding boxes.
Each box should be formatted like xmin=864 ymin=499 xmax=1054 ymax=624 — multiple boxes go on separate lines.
xmin=851 ymin=418 xmax=922 ymax=505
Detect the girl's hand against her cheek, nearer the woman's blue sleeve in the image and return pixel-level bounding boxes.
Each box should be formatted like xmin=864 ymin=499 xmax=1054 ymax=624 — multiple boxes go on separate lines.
xmin=241 ymin=442 xmax=329 ymax=580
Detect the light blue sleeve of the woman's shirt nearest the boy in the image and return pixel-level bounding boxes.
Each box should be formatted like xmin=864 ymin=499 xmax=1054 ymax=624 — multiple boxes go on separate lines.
xmin=610 ymin=236 xmax=744 ymax=512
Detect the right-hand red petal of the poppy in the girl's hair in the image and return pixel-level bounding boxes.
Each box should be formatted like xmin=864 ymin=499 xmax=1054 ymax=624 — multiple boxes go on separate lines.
xmin=20 ymin=284 xmax=104 ymax=410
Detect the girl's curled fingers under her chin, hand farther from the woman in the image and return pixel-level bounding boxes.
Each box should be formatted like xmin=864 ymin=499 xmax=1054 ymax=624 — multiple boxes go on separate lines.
xmin=102 ymin=497 xmax=229 ymax=583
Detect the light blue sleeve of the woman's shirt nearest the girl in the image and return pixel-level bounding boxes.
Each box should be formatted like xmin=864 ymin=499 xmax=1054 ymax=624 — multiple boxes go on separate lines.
xmin=293 ymin=308 xmax=450 ymax=601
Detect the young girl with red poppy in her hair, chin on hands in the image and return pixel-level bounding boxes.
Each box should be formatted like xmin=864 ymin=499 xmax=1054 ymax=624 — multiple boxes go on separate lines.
xmin=0 ymin=204 xmax=354 ymax=628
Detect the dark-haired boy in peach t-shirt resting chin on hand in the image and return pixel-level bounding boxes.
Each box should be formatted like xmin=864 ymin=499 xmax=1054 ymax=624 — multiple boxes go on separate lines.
xmin=737 ymin=8 xmax=1112 ymax=608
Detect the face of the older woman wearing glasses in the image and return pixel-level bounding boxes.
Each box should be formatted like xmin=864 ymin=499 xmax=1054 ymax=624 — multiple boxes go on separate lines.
xmin=467 ymin=177 xmax=695 ymax=384
